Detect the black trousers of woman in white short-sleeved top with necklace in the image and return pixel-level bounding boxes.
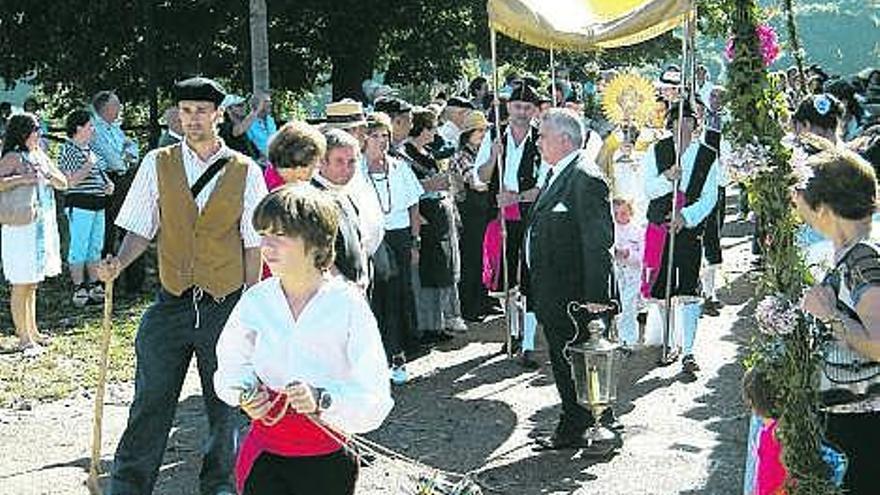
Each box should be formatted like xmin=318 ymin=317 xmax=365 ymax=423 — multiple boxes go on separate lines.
xmin=370 ymin=228 xmax=418 ymax=361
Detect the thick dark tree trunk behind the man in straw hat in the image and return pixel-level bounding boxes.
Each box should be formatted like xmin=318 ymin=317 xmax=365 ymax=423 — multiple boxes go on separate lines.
xmin=328 ymin=2 xmax=381 ymax=101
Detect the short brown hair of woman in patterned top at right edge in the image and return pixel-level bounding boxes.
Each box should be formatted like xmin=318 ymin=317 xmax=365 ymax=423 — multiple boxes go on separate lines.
xmin=803 ymin=148 xmax=877 ymax=220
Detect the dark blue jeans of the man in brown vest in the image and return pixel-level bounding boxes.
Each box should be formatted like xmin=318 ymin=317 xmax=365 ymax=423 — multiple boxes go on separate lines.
xmin=110 ymin=290 xmax=240 ymax=495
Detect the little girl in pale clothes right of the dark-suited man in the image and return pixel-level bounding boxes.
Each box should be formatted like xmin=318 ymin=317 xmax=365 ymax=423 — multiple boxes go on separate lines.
xmin=612 ymin=198 xmax=645 ymax=346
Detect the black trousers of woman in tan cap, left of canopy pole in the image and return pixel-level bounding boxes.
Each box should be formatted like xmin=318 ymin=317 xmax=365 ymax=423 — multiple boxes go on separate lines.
xmin=458 ymin=189 xmax=489 ymax=318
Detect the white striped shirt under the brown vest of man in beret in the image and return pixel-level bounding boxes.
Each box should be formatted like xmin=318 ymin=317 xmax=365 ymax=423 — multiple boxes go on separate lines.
xmin=116 ymin=140 xmax=268 ymax=248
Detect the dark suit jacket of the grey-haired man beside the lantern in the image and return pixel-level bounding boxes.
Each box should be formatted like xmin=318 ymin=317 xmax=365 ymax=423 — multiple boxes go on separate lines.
xmin=528 ymin=157 xmax=614 ymax=329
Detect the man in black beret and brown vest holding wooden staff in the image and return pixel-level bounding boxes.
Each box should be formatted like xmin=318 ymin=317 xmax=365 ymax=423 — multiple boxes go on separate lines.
xmin=98 ymin=77 xmax=266 ymax=495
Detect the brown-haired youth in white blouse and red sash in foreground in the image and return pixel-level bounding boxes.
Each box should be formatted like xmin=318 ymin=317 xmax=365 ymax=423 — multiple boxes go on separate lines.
xmin=214 ymin=185 xmax=393 ymax=495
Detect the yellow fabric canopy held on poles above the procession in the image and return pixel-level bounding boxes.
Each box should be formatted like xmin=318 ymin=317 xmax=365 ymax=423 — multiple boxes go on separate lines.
xmin=487 ymin=0 xmax=692 ymax=51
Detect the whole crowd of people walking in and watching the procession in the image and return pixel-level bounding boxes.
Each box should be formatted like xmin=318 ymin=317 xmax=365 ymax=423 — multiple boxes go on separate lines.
xmin=0 ymin=59 xmax=880 ymax=494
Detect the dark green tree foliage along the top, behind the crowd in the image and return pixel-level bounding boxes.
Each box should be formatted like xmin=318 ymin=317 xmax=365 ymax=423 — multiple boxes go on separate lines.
xmin=0 ymin=0 xmax=696 ymax=114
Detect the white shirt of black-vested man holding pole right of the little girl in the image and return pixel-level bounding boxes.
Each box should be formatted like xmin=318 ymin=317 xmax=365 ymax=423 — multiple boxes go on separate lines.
xmin=642 ymin=141 xmax=718 ymax=228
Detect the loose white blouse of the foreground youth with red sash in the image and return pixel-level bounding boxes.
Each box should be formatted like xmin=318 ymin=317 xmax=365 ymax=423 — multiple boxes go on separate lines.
xmin=214 ymin=277 xmax=394 ymax=433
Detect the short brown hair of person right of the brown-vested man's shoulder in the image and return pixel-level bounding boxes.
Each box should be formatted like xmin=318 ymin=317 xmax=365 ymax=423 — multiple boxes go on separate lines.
xmin=269 ymin=121 xmax=327 ymax=168
